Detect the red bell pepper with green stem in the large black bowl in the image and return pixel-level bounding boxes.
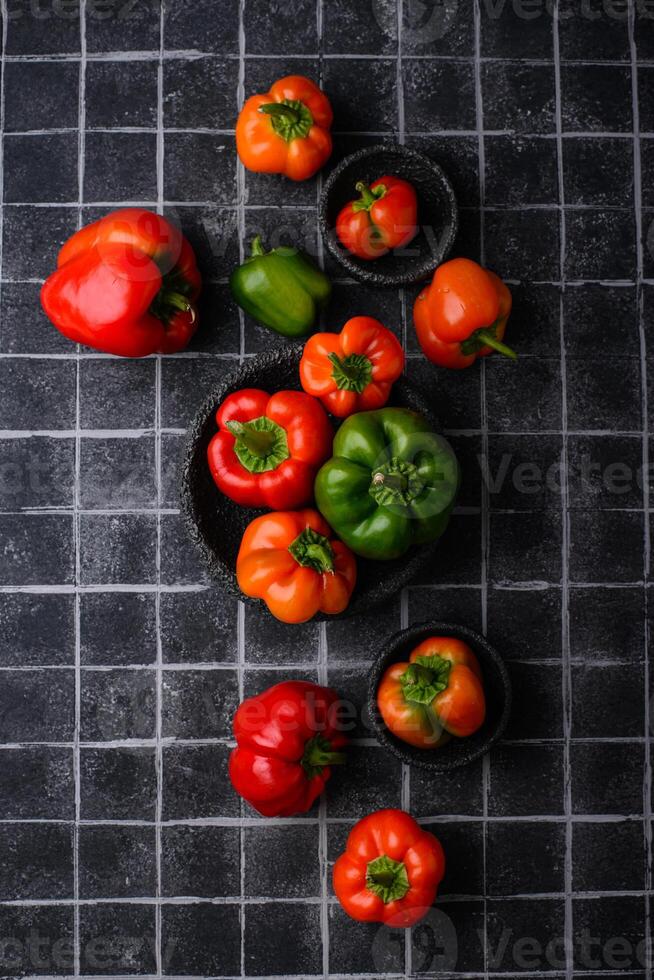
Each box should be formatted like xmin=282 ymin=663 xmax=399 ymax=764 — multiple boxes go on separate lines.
xmin=207 ymin=388 xmax=334 ymax=510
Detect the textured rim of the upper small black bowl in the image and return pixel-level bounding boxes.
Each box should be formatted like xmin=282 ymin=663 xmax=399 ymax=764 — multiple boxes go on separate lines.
xmin=318 ymin=142 xmax=459 ymax=288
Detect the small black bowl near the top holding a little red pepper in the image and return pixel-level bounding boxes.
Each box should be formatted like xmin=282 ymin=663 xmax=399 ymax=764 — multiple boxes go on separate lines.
xmin=318 ymin=143 xmax=459 ymax=287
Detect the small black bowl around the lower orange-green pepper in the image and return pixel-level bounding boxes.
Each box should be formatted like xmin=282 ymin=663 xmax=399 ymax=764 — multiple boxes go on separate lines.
xmin=368 ymin=623 xmax=511 ymax=773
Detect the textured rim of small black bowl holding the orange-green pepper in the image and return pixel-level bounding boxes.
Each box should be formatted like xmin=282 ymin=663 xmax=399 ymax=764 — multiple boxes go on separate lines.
xmin=367 ymin=622 xmax=512 ymax=773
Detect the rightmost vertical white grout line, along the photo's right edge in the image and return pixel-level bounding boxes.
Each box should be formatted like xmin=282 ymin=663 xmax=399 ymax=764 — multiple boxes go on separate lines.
xmin=628 ymin=2 xmax=652 ymax=980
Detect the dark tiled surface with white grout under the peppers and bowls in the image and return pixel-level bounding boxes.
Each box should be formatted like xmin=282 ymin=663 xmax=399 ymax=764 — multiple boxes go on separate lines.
xmin=0 ymin=0 xmax=654 ymax=980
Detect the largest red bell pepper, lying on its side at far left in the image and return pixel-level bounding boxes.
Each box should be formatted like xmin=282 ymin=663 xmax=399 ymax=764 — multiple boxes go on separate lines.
xmin=41 ymin=208 xmax=201 ymax=357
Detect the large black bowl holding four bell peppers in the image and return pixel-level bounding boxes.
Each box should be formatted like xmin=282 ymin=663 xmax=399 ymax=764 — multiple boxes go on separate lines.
xmin=181 ymin=344 xmax=456 ymax=619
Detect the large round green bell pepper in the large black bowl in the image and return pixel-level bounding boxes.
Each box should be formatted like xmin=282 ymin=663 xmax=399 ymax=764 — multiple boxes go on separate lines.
xmin=314 ymin=408 xmax=459 ymax=560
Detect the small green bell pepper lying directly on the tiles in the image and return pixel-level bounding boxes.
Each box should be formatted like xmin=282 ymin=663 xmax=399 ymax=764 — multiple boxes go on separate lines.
xmin=229 ymin=235 xmax=332 ymax=337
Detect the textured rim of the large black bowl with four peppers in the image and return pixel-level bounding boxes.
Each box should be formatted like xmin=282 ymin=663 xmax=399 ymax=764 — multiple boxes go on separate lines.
xmin=180 ymin=344 xmax=456 ymax=622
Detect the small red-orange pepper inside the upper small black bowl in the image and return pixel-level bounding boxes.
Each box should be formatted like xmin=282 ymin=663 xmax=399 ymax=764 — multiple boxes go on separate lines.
xmin=336 ymin=176 xmax=418 ymax=259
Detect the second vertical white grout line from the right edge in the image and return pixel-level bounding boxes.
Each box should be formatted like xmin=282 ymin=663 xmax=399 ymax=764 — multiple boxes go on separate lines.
xmin=552 ymin=7 xmax=574 ymax=980
